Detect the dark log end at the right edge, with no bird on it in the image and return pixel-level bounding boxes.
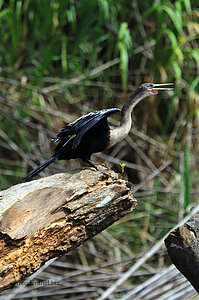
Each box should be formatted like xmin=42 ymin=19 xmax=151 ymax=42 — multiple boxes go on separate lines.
xmin=165 ymin=215 xmax=199 ymax=293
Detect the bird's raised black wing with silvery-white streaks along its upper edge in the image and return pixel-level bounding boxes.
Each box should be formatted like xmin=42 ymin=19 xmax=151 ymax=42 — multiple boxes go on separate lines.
xmin=53 ymin=108 xmax=120 ymax=152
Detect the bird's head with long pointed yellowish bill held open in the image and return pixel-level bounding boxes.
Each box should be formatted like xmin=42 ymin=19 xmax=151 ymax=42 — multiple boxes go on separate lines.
xmin=140 ymin=83 xmax=174 ymax=96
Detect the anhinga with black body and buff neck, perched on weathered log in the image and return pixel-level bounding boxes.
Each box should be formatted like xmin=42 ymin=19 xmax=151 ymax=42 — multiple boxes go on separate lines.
xmin=20 ymin=83 xmax=173 ymax=183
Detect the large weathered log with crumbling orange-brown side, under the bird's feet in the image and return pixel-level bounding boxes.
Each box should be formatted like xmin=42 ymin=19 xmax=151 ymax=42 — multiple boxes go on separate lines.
xmin=0 ymin=168 xmax=136 ymax=290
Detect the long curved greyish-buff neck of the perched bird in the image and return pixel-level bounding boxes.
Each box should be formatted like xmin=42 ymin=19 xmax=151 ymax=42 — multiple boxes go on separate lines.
xmin=120 ymin=88 xmax=146 ymax=130
